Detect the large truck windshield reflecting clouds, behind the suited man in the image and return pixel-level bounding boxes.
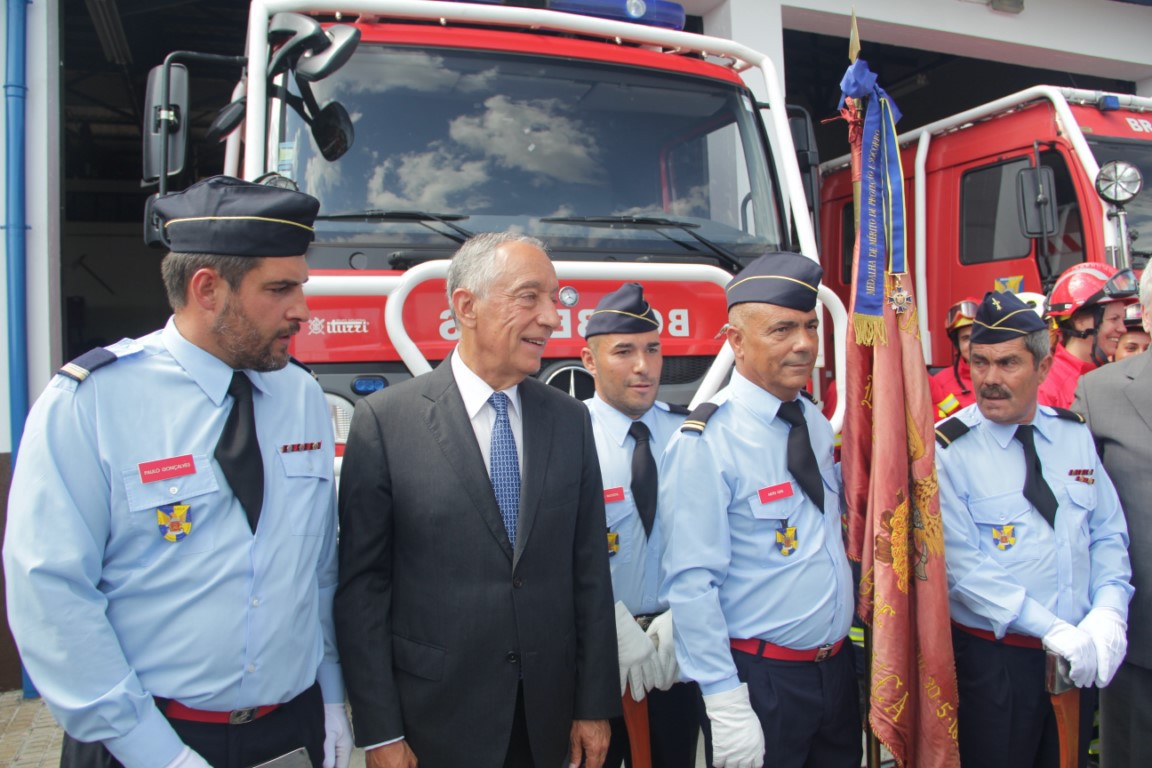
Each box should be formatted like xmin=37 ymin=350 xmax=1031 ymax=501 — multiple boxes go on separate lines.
xmin=272 ymin=44 xmax=788 ymax=269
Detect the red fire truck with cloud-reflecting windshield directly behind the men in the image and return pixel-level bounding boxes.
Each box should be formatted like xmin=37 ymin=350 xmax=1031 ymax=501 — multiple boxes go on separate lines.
xmin=145 ymin=0 xmax=843 ymax=451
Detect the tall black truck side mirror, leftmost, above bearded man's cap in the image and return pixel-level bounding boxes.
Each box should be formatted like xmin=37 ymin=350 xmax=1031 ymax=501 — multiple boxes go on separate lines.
xmin=143 ymin=64 xmax=188 ymax=184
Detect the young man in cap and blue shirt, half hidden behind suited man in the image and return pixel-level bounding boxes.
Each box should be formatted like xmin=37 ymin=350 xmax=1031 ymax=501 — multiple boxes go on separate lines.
xmin=583 ymin=283 xmax=699 ymax=768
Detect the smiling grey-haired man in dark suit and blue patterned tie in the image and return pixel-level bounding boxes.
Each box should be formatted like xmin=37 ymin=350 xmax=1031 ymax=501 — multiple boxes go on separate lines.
xmin=335 ymin=233 xmax=620 ymax=768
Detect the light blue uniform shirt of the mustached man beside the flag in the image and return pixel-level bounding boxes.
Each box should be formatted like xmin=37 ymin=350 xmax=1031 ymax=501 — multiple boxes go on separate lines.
xmin=937 ymin=404 xmax=1132 ymax=637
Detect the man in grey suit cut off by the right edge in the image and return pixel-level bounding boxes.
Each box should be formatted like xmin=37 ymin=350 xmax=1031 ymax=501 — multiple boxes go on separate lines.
xmin=1073 ymin=268 xmax=1152 ymax=768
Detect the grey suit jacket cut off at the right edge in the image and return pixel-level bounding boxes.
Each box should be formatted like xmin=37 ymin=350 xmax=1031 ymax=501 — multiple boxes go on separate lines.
xmin=1073 ymin=351 xmax=1152 ymax=669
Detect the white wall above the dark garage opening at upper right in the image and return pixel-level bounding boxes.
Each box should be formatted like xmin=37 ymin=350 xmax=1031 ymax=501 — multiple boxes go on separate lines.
xmin=681 ymin=0 xmax=1152 ymax=96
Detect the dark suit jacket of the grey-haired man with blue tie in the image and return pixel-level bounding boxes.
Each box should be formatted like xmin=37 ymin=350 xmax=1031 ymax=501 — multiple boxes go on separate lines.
xmin=335 ymin=360 xmax=620 ymax=768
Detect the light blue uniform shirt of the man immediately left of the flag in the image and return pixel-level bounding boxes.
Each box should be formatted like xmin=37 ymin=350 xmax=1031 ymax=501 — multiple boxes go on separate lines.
xmin=659 ymin=372 xmax=854 ymax=695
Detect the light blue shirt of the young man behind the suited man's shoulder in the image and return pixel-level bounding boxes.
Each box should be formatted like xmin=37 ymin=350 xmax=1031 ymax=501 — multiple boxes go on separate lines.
xmin=584 ymin=395 xmax=684 ymax=616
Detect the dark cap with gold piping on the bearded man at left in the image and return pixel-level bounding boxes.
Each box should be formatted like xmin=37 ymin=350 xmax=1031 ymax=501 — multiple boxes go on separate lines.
xmin=152 ymin=176 xmax=320 ymax=256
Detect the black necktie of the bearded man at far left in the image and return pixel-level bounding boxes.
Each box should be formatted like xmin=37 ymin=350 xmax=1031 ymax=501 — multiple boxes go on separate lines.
xmin=215 ymin=371 xmax=264 ymax=533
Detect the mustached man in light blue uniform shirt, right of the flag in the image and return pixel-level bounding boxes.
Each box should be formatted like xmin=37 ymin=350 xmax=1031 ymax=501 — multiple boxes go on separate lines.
xmin=937 ymin=292 xmax=1132 ymax=768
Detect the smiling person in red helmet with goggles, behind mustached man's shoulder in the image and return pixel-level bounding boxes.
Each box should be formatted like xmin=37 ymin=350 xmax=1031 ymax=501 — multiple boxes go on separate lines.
xmin=1038 ymin=261 xmax=1136 ymax=408
